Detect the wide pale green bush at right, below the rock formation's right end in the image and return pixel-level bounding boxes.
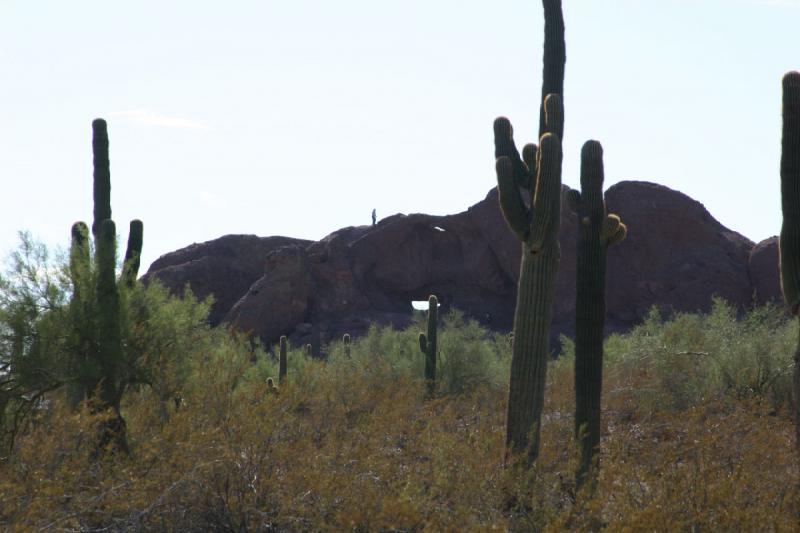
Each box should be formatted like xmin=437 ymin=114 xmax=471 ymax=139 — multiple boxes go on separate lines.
xmin=606 ymin=299 xmax=797 ymax=410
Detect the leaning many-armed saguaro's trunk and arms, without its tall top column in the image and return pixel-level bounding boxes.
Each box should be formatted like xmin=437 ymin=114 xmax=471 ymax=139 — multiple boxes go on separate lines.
xmin=494 ymin=94 xmax=563 ymax=463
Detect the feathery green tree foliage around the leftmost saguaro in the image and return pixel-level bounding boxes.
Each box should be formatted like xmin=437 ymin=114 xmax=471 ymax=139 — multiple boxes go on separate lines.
xmin=0 ymin=231 xmax=216 ymax=450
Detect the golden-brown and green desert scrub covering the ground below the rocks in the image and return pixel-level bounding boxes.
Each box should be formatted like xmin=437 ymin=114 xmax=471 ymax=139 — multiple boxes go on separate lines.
xmin=0 ymin=270 xmax=800 ymax=532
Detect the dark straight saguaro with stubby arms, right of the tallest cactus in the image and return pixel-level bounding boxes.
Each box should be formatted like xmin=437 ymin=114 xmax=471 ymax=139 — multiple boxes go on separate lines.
xmin=567 ymin=141 xmax=627 ymax=485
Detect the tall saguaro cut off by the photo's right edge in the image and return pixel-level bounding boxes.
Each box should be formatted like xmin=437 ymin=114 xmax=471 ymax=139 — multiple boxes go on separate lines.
xmin=780 ymin=72 xmax=800 ymax=449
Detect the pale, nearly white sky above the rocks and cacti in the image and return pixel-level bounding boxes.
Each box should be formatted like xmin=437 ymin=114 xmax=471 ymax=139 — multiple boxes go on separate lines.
xmin=0 ymin=0 xmax=800 ymax=272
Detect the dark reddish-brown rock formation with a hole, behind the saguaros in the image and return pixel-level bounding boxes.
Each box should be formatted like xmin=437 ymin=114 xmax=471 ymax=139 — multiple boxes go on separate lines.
xmin=146 ymin=181 xmax=779 ymax=343
